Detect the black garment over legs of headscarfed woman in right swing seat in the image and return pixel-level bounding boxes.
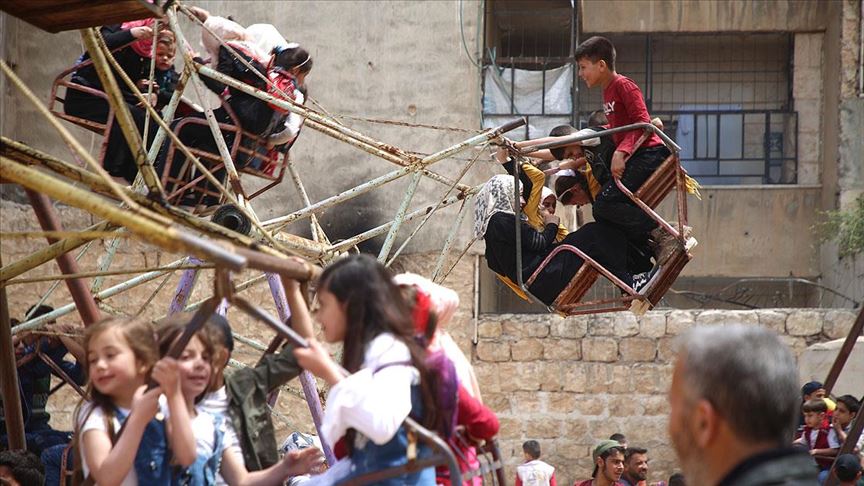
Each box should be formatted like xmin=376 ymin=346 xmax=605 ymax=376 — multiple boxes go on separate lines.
xmin=523 ymin=223 xmax=633 ymax=304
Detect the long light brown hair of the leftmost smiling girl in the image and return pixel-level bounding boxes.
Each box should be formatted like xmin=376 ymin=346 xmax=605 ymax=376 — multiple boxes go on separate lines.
xmin=72 ymin=317 xmax=159 ymax=478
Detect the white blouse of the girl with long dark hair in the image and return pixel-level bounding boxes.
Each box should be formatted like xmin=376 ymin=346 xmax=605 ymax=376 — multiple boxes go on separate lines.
xmin=321 ymin=333 xmax=420 ymax=445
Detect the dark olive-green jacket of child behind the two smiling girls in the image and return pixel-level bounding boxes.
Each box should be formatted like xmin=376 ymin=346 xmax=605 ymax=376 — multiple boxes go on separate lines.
xmin=225 ymin=343 xmax=303 ymax=471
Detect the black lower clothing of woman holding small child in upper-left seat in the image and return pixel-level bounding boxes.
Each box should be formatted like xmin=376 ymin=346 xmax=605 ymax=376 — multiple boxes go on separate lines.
xmin=63 ymin=89 xmax=159 ymax=184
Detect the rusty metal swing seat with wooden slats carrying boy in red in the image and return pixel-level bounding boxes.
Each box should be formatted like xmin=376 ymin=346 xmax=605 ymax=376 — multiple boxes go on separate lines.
xmin=514 ymin=123 xmax=697 ymax=316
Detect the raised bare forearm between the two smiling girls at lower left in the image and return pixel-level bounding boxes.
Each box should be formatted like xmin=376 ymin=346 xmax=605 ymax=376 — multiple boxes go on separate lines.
xmin=152 ymin=358 xmax=197 ymax=467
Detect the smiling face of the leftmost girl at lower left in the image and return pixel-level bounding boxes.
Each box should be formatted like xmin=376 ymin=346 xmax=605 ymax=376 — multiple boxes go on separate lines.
xmin=87 ymin=327 xmax=146 ymax=397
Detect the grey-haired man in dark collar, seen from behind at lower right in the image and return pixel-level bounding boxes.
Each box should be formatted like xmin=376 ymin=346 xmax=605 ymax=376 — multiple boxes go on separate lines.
xmin=669 ymin=325 xmax=817 ymax=486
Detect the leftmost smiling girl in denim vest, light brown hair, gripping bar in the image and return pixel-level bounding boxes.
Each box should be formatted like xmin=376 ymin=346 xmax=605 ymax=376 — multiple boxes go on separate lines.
xmin=75 ymin=319 xmax=195 ymax=486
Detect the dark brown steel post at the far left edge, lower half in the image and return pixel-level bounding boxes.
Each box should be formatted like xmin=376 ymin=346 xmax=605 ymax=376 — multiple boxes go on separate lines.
xmin=0 ymin=260 xmax=27 ymax=450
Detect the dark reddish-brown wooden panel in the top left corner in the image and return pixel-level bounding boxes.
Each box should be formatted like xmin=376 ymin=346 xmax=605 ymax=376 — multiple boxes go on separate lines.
xmin=0 ymin=0 xmax=163 ymax=33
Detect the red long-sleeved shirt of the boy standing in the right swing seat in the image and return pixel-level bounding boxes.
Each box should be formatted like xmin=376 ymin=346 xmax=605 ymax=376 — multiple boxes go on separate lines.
xmin=603 ymin=74 xmax=663 ymax=155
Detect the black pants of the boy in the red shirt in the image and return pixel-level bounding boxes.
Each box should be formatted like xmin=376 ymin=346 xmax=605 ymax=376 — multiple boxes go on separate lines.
xmin=593 ymin=145 xmax=670 ymax=248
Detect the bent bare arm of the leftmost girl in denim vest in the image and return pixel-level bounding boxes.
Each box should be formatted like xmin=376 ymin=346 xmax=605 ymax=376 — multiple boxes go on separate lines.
xmin=81 ymin=386 xmax=162 ymax=486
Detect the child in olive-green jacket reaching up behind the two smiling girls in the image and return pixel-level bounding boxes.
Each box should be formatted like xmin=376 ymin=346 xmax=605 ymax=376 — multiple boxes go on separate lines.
xmin=198 ymin=280 xmax=312 ymax=471
